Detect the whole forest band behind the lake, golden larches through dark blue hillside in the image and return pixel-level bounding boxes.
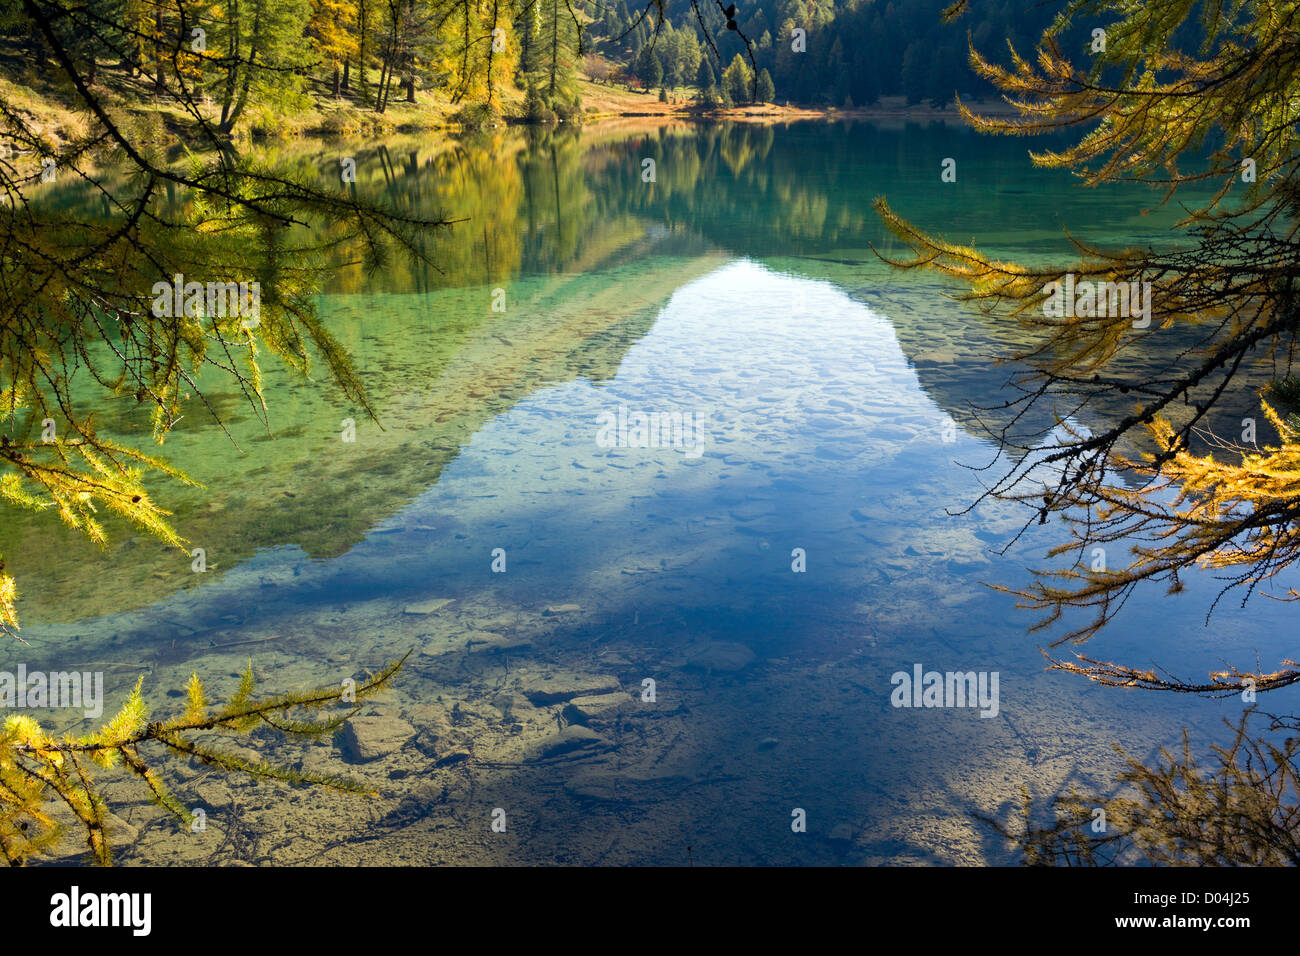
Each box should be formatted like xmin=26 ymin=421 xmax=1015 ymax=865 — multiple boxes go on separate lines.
xmin=0 ymin=0 xmax=1107 ymax=124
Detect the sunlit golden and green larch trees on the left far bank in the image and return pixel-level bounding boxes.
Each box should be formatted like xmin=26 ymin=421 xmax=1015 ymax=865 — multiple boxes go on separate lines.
xmin=0 ymin=0 xmax=582 ymax=125
